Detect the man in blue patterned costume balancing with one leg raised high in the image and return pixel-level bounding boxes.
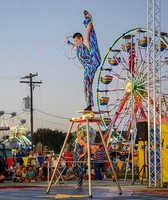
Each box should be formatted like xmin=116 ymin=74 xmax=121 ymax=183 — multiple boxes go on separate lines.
xmin=67 ymin=10 xmax=101 ymax=110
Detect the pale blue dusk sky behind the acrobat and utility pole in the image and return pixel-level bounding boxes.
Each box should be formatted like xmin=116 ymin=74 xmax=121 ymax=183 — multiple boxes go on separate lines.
xmin=0 ymin=0 xmax=168 ymax=134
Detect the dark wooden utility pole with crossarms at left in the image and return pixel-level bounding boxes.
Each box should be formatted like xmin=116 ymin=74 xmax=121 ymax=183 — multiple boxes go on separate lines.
xmin=20 ymin=73 xmax=42 ymax=150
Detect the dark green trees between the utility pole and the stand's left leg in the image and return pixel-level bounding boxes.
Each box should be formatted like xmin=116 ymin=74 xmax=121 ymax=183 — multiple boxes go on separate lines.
xmin=33 ymin=128 xmax=67 ymax=153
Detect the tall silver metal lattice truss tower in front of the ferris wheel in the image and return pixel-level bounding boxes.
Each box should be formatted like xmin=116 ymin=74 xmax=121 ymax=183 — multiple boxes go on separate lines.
xmin=147 ymin=0 xmax=162 ymax=187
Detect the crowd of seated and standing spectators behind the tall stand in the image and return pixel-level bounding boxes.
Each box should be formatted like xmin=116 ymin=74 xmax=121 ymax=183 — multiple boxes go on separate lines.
xmin=0 ymin=141 xmax=136 ymax=189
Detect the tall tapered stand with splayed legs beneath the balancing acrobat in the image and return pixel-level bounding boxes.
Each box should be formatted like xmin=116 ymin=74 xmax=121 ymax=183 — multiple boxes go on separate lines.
xmin=46 ymin=115 xmax=122 ymax=197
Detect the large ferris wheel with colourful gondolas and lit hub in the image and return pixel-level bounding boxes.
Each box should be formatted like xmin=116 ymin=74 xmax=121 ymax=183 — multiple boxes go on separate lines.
xmin=97 ymin=28 xmax=168 ymax=139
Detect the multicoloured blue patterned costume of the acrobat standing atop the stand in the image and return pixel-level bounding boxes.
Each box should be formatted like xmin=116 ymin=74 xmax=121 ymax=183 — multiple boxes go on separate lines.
xmin=76 ymin=17 xmax=101 ymax=106
